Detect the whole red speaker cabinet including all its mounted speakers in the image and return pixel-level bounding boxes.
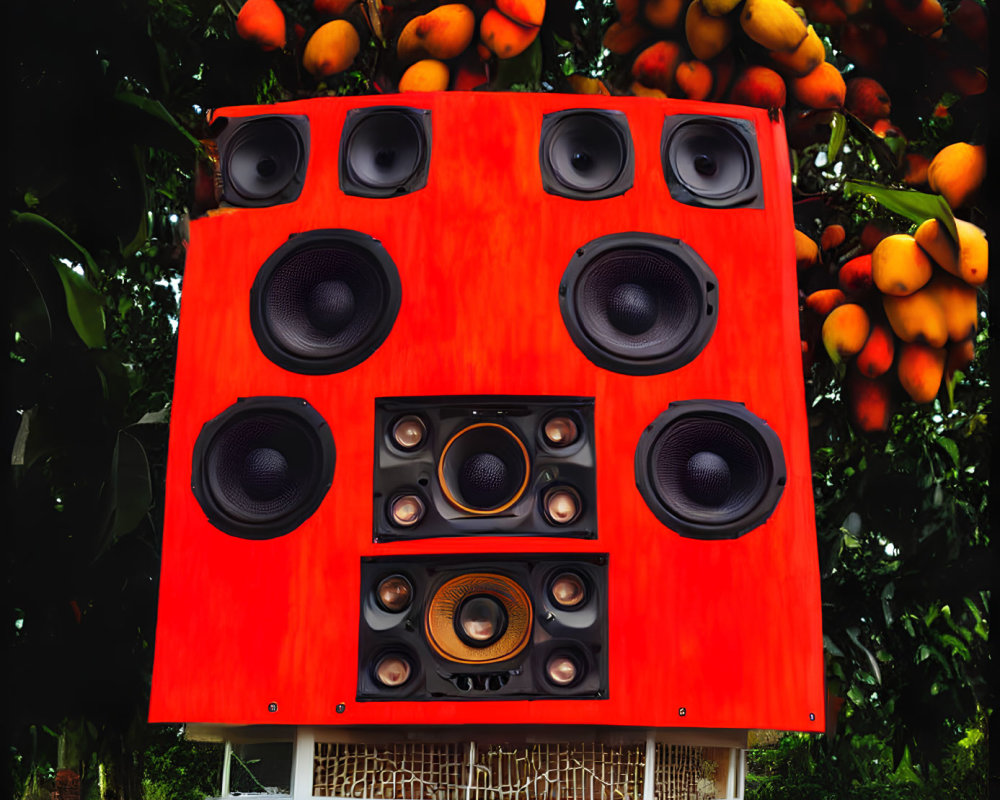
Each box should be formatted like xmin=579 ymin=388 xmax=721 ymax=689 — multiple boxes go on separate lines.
xmin=150 ymin=92 xmax=824 ymax=731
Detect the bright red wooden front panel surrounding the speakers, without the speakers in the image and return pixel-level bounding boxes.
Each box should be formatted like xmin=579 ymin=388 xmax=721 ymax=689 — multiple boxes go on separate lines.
xmin=150 ymin=92 xmax=824 ymax=731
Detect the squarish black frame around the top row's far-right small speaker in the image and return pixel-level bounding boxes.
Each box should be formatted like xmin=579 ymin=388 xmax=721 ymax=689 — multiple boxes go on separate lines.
xmin=660 ymin=114 xmax=764 ymax=208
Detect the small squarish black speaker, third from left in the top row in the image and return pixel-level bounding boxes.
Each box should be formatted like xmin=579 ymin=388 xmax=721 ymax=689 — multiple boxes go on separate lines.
xmin=538 ymin=109 xmax=635 ymax=200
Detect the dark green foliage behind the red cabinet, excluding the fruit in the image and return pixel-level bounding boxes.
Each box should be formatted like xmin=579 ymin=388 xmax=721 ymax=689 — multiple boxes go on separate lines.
xmin=3 ymin=0 xmax=994 ymax=798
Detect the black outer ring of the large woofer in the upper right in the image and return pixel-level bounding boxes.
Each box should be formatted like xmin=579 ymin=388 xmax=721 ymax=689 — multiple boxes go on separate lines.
xmin=559 ymin=232 xmax=719 ymax=375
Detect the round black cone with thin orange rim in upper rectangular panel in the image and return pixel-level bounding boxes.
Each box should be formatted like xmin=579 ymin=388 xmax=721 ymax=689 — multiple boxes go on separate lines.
xmin=438 ymin=422 xmax=531 ymax=515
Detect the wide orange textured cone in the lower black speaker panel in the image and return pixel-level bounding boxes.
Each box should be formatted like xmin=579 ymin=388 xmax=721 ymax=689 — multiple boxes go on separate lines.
xmin=424 ymin=573 xmax=533 ymax=664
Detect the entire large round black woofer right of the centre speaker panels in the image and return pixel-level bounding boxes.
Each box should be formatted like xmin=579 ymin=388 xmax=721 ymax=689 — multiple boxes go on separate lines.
xmin=635 ymin=400 xmax=785 ymax=539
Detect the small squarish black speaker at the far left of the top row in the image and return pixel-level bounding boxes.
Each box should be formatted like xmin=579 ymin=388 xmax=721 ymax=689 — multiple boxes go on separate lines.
xmin=216 ymin=115 xmax=309 ymax=207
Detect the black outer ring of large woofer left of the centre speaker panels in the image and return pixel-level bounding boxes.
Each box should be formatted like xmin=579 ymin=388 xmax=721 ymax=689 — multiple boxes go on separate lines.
xmin=191 ymin=397 xmax=336 ymax=540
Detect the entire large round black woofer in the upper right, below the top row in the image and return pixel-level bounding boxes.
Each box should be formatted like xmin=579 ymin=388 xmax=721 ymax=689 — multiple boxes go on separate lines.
xmin=559 ymin=233 xmax=718 ymax=375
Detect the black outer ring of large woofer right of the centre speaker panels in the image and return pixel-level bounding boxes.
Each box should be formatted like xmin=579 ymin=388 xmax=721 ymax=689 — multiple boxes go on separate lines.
xmin=635 ymin=400 xmax=787 ymax=539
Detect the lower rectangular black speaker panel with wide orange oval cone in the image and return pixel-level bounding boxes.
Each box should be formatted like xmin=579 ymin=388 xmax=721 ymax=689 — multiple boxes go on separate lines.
xmin=358 ymin=553 xmax=608 ymax=700
